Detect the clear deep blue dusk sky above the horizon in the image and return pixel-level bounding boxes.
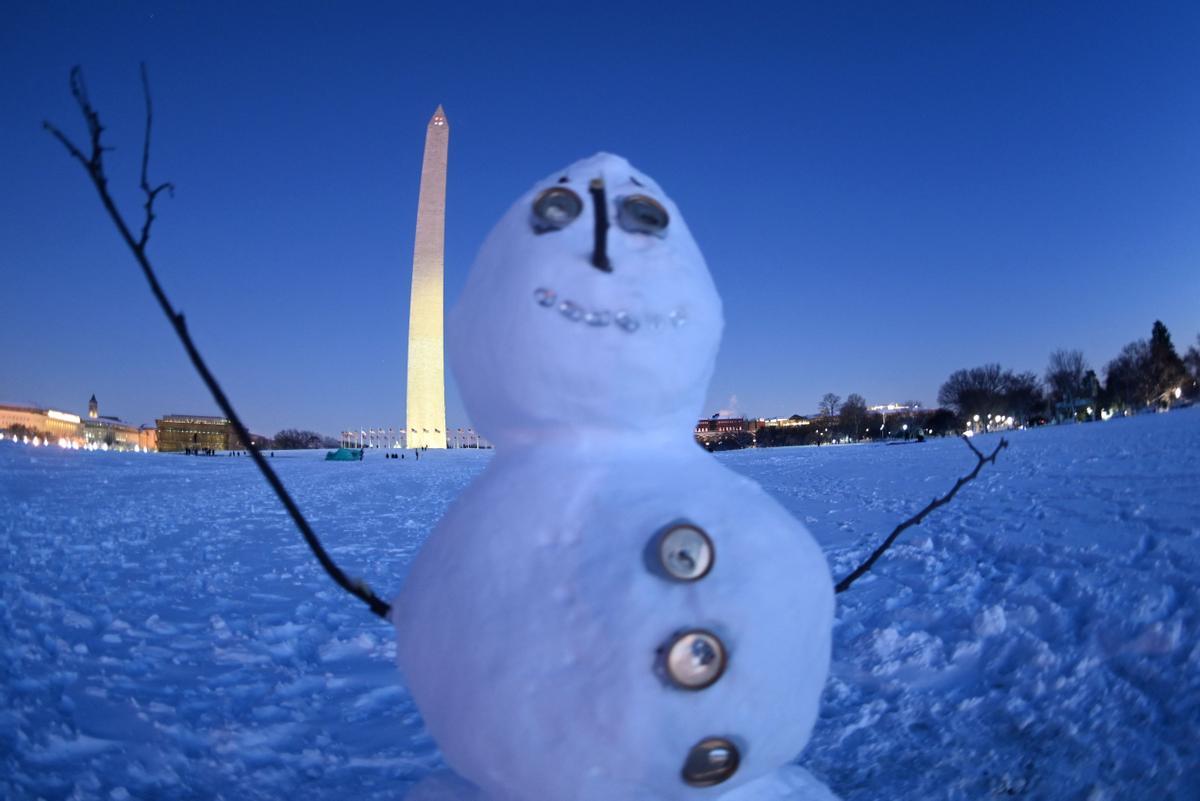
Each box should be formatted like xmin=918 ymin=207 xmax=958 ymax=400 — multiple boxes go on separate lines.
xmin=0 ymin=2 xmax=1200 ymax=435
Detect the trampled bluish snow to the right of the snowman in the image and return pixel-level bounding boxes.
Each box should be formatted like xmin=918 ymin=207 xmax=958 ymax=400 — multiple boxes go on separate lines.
xmin=728 ymin=409 xmax=1200 ymax=801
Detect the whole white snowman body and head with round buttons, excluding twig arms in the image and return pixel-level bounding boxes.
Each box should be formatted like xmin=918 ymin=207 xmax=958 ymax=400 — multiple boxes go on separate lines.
xmin=392 ymin=153 xmax=833 ymax=801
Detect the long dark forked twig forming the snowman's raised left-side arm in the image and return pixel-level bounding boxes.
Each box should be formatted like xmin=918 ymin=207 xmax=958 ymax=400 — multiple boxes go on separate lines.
xmin=42 ymin=64 xmax=391 ymax=619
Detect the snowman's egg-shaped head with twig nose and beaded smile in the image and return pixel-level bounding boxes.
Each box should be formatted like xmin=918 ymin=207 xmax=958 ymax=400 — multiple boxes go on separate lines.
xmin=448 ymin=153 xmax=722 ymax=444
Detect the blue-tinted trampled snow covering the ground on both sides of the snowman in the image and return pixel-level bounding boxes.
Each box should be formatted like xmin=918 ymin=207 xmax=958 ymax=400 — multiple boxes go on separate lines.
xmin=0 ymin=409 xmax=1200 ymax=801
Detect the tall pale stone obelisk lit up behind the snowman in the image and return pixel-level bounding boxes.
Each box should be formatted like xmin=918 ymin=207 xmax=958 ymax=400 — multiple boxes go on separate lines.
xmin=406 ymin=106 xmax=450 ymax=447
